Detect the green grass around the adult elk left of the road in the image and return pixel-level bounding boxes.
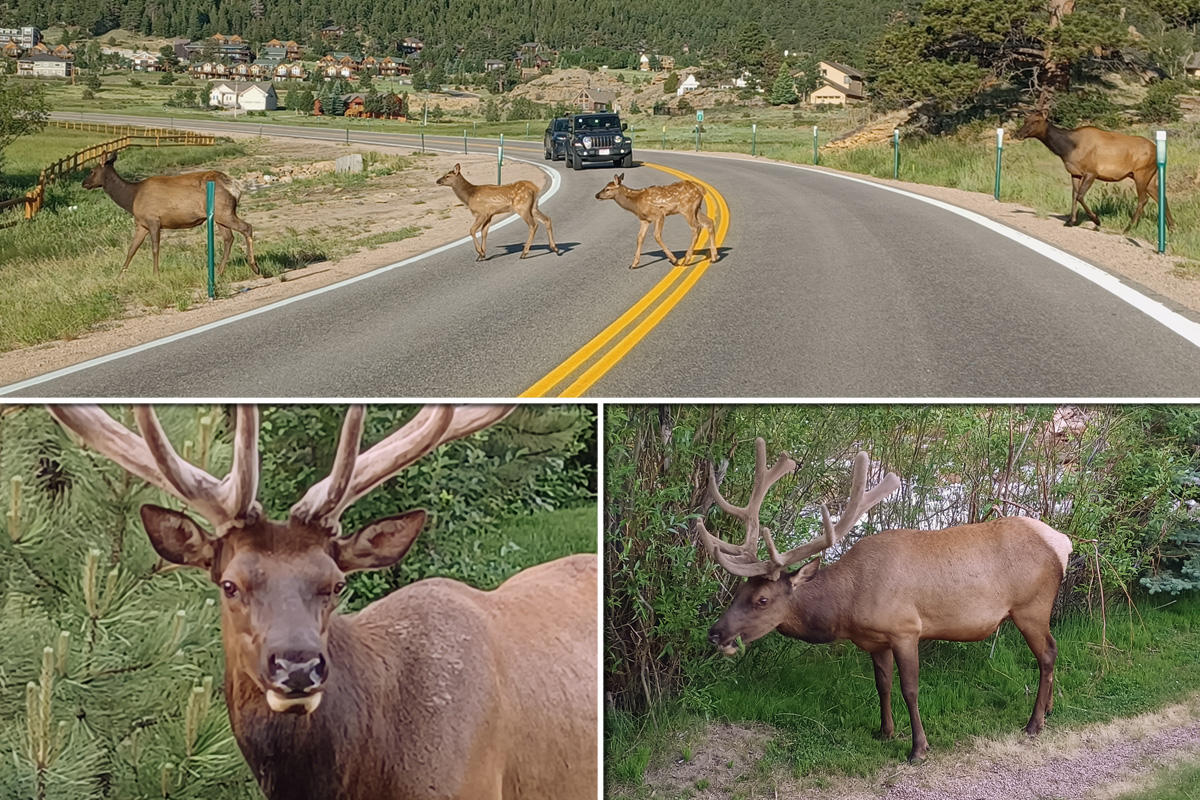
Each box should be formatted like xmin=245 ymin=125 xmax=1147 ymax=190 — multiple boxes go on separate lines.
xmin=0 ymin=134 xmax=420 ymax=351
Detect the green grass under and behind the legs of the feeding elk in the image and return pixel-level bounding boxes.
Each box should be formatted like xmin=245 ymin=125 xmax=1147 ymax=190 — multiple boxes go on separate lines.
xmin=606 ymin=597 xmax=1200 ymax=798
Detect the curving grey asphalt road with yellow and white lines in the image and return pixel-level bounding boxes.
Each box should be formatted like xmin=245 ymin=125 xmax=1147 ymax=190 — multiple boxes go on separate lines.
xmin=11 ymin=115 xmax=1200 ymax=398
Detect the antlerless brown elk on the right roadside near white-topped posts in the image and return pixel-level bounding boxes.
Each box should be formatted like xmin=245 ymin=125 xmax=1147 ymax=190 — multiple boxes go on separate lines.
xmin=1013 ymin=110 xmax=1175 ymax=233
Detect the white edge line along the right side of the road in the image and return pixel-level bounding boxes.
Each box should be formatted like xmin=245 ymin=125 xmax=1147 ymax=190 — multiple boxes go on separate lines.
xmin=700 ymin=154 xmax=1200 ymax=348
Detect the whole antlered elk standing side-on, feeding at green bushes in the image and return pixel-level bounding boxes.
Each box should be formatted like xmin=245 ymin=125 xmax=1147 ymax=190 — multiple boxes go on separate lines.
xmin=697 ymin=439 xmax=1072 ymax=762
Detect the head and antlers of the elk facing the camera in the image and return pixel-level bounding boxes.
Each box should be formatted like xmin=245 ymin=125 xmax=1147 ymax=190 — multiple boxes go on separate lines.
xmin=49 ymin=405 xmax=512 ymax=714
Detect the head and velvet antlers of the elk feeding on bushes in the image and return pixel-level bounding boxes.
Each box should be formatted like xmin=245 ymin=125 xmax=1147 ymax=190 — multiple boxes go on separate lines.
xmin=696 ymin=438 xmax=900 ymax=656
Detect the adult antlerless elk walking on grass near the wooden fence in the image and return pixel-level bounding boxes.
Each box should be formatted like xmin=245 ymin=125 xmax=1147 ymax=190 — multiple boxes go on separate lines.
xmin=83 ymin=151 xmax=259 ymax=275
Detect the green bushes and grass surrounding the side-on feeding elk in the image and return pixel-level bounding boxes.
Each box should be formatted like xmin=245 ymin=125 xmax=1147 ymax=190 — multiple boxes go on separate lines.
xmin=605 ymin=405 xmax=1200 ymax=798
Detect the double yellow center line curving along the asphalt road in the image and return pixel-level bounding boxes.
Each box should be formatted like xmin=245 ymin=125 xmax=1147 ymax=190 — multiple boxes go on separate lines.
xmin=520 ymin=163 xmax=730 ymax=397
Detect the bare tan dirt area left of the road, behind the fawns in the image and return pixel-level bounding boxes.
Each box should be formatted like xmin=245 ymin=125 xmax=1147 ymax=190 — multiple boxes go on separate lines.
xmin=0 ymin=131 xmax=548 ymax=386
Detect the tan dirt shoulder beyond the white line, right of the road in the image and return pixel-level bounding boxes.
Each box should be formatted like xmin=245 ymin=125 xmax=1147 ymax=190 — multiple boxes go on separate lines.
xmin=691 ymin=154 xmax=1200 ymax=321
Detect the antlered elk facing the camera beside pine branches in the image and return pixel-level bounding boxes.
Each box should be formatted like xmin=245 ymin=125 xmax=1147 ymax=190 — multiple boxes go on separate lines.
xmin=49 ymin=405 xmax=599 ymax=800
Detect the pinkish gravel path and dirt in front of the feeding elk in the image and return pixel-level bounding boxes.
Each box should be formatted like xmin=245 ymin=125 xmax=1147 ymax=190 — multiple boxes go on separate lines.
xmin=646 ymin=694 xmax=1200 ymax=800
